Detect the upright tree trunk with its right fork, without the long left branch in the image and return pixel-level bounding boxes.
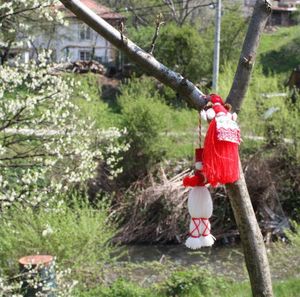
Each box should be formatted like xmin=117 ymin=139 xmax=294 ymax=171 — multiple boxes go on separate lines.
xmin=226 ymin=0 xmax=273 ymax=297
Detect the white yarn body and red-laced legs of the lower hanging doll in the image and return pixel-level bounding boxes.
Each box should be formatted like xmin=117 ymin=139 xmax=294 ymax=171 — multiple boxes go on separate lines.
xmin=185 ymin=187 xmax=215 ymax=249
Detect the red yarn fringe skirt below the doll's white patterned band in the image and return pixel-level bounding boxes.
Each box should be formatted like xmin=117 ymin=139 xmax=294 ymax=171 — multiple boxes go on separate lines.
xmin=203 ymin=119 xmax=240 ymax=187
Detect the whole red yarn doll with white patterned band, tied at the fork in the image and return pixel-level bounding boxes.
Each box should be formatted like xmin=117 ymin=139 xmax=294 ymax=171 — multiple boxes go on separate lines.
xmin=201 ymin=94 xmax=241 ymax=187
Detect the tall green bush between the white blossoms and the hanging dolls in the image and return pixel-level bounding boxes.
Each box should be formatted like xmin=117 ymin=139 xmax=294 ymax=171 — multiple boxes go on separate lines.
xmin=118 ymin=78 xmax=169 ymax=182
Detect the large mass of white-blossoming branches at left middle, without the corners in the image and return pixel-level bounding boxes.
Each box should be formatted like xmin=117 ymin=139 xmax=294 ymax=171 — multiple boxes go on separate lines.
xmin=0 ymin=55 xmax=126 ymax=207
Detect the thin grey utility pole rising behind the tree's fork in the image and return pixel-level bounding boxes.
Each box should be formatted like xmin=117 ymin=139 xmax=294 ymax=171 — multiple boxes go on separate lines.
xmin=212 ymin=0 xmax=221 ymax=93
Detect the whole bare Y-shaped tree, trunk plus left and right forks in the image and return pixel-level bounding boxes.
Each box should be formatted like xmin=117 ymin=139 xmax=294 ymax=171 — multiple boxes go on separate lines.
xmin=60 ymin=0 xmax=273 ymax=297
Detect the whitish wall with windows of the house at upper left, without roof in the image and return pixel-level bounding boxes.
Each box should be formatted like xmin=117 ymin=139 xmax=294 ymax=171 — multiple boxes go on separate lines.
xmin=31 ymin=18 xmax=115 ymax=63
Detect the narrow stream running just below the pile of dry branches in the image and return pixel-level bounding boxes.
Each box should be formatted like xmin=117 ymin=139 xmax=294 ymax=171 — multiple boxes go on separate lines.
xmin=119 ymin=244 xmax=300 ymax=283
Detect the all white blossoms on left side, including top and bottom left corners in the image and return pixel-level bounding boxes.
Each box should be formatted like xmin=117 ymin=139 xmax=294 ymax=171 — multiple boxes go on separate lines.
xmin=0 ymin=0 xmax=127 ymax=296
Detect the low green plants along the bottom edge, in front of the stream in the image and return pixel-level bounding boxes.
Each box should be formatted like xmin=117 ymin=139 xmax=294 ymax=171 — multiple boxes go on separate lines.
xmin=73 ymin=266 xmax=300 ymax=297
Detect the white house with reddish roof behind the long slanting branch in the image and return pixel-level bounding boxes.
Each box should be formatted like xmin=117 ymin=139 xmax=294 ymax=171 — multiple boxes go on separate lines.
xmin=24 ymin=0 xmax=124 ymax=64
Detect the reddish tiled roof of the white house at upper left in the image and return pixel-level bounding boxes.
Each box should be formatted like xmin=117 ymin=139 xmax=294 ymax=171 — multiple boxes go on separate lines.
xmin=58 ymin=0 xmax=124 ymax=20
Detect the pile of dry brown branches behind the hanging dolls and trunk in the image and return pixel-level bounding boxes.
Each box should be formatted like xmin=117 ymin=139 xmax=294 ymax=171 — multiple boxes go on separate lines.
xmin=113 ymin=149 xmax=296 ymax=243
